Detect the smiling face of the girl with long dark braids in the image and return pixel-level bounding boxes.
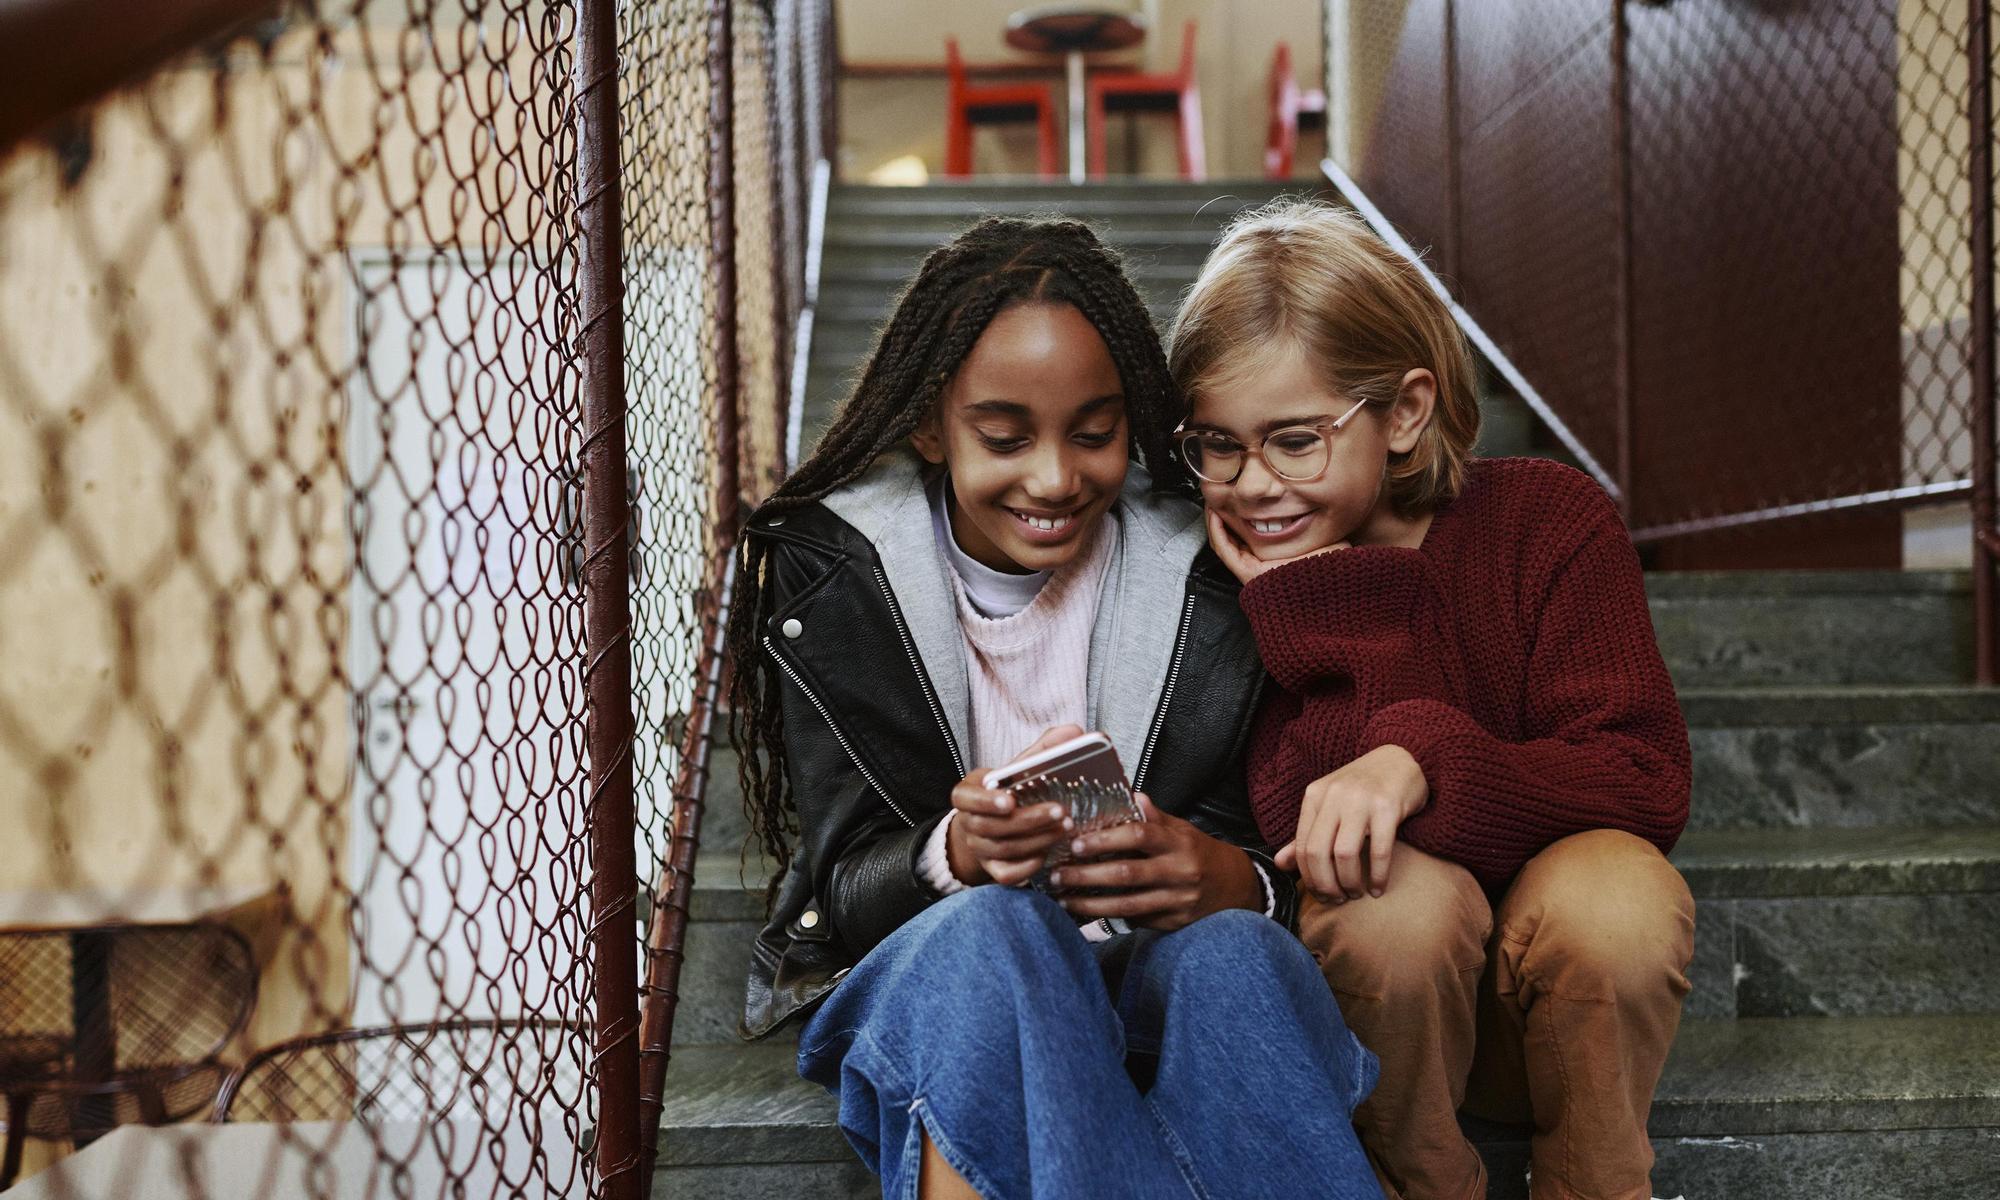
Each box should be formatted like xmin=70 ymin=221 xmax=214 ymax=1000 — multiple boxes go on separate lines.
xmin=910 ymin=304 xmax=1130 ymax=572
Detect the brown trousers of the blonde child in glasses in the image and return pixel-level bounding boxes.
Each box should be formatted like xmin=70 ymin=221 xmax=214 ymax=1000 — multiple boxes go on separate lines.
xmin=1298 ymin=830 xmax=1694 ymax=1200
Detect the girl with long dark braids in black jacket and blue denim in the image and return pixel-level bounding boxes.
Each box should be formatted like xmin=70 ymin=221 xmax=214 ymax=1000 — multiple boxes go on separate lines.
xmin=728 ymin=218 xmax=1376 ymax=1198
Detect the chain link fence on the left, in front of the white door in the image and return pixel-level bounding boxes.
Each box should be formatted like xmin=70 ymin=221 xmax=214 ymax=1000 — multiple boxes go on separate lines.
xmin=0 ymin=0 xmax=830 ymax=1196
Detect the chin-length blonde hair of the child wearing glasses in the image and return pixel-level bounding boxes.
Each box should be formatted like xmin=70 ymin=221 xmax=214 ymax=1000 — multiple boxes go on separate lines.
xmin=1168 ymin=198 xmax=1480 ymax=514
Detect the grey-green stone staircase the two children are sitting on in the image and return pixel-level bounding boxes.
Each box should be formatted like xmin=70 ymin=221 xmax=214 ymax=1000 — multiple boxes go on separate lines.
xmin=654 ymin=182 xmax=2000 ymax=1200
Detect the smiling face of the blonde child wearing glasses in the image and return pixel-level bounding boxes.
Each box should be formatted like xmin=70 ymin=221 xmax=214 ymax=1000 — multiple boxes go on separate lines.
xmin=1186 ymin=344 xmax=1436 ymax=560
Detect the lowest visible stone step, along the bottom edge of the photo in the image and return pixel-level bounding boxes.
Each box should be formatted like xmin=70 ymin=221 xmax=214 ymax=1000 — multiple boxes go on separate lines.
xmin=654 ymin=1016 xmax=2000 ymax=1200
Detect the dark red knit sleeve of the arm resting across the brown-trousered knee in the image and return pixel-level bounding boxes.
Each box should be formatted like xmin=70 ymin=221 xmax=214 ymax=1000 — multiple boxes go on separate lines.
xmin=1356 ymin=512 xmax=1690 ymax=888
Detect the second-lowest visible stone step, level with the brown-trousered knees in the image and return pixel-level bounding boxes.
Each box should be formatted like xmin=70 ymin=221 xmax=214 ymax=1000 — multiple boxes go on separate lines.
xmin=674 ymin=824 xmax=2000 ymax=1044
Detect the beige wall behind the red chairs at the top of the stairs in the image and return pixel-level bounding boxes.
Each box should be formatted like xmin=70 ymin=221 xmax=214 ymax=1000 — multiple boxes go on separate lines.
xmin=838 ymin=0 xmax=1320 ymax=180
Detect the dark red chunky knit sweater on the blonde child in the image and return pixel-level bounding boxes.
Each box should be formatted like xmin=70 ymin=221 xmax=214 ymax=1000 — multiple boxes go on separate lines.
xmin=1242 ymin=458 xmax=1688 ymax=890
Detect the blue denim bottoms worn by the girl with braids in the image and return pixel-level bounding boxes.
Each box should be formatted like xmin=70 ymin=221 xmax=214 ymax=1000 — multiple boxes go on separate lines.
xmin=798 ymin=886 xmax=1382 ymax=1200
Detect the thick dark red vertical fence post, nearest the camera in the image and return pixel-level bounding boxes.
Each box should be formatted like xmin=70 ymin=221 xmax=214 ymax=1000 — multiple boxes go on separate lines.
xmin=576 ymin=0 xmax=646 ymax=1200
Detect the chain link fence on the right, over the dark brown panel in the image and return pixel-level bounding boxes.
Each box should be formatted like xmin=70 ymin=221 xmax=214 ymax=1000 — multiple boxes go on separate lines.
xmin=1326 ymin=0 xmax=1996 ymax=672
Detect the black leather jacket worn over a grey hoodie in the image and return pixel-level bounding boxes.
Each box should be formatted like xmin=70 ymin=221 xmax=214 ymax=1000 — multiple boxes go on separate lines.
xmin=742 ymin=468 xmax=1298 ymax=1038
